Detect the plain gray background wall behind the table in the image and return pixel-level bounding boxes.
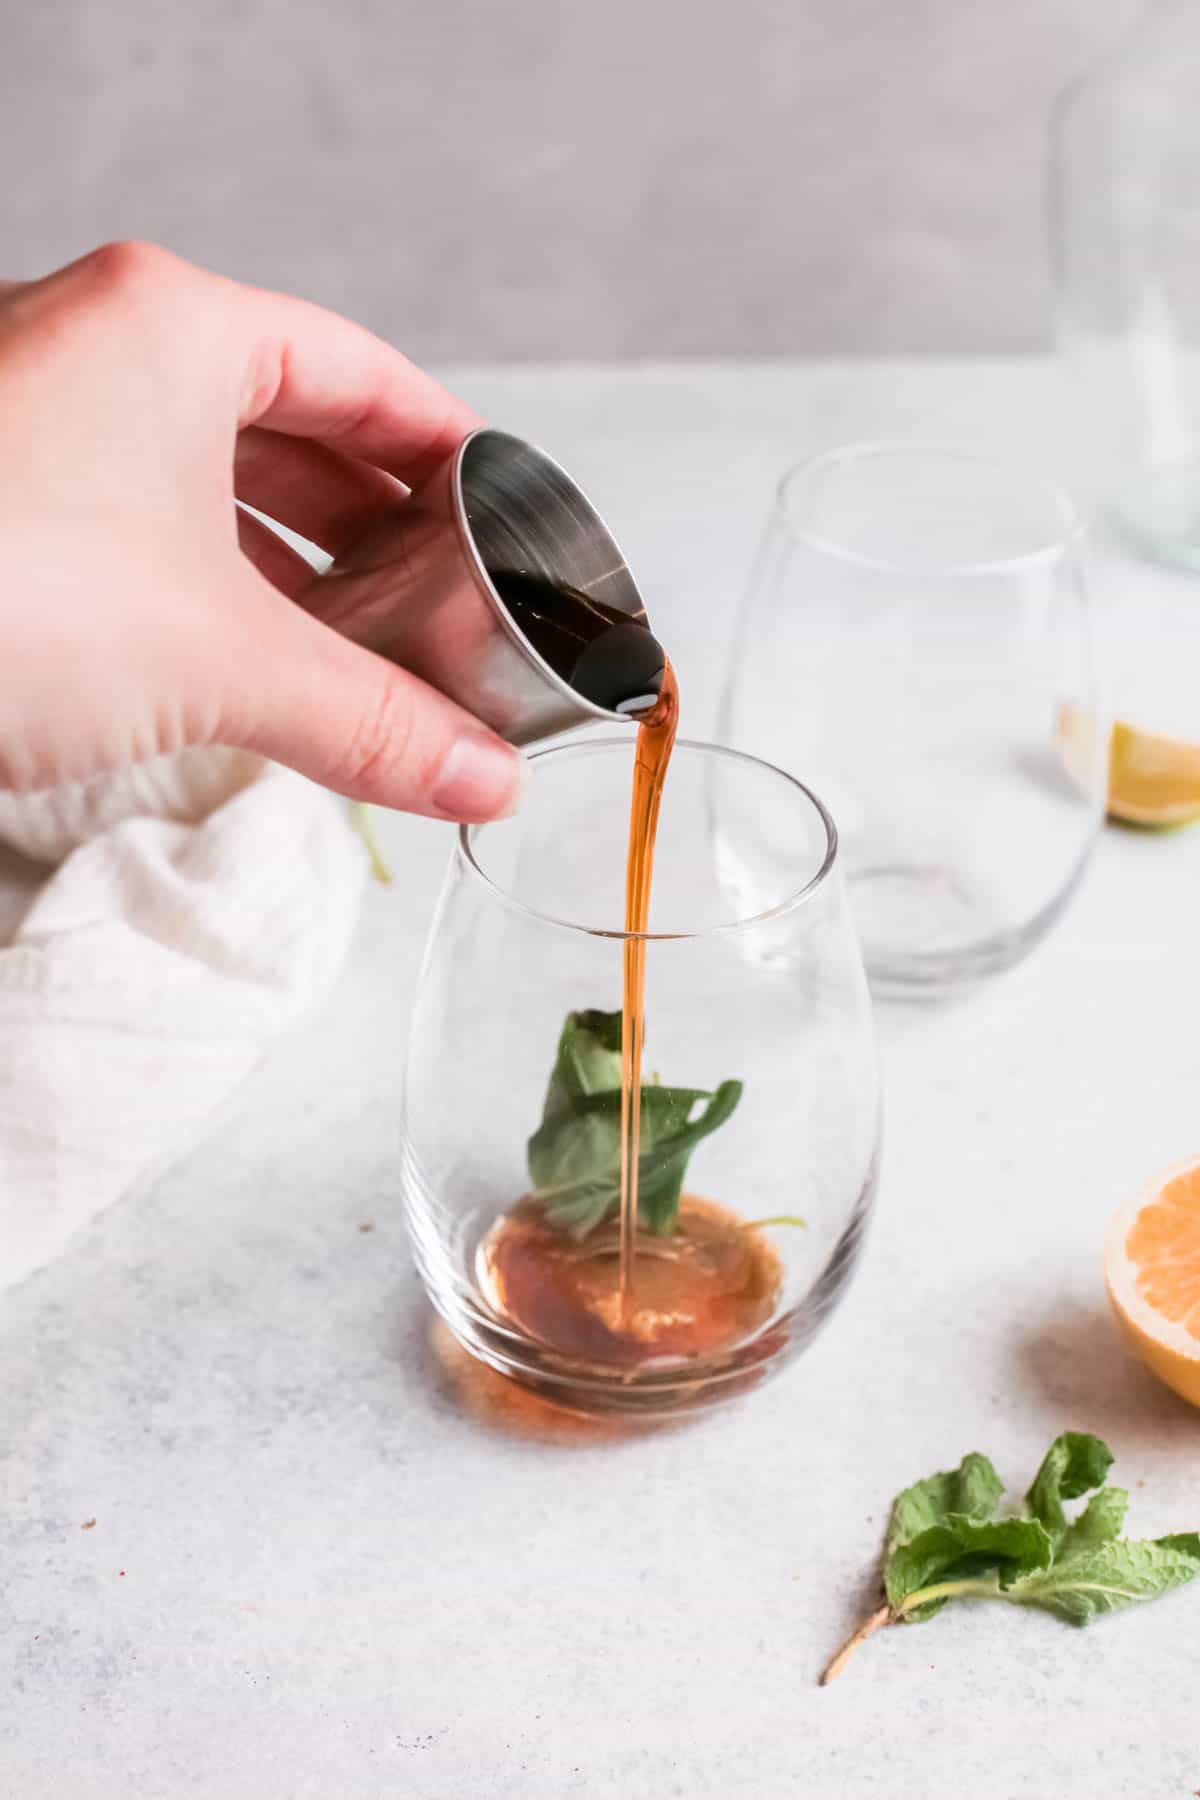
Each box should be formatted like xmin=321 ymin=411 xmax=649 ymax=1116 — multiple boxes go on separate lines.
xmin=0 ymin=0 xmax=1139 ymax=360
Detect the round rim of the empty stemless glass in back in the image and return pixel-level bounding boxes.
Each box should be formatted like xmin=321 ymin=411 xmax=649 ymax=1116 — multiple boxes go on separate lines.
xmin=774 ymin=437 xmax=1085 ymax=580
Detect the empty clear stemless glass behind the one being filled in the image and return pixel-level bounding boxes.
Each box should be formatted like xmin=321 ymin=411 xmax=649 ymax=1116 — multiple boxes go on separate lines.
xmin=718 ymin=443 xmax=1106 ymax=992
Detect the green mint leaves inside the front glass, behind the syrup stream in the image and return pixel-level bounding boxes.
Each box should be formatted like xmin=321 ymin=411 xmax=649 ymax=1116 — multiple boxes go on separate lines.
xmin=527 ymin=1010 xmax=741 ymax=1238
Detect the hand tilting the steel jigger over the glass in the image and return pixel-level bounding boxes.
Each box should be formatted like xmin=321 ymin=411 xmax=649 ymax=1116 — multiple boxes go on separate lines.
xmin=0 ymin=245 xmax=520 ymax=819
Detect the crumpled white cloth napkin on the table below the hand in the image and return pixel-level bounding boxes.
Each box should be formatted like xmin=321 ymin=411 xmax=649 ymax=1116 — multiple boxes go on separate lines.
xmin=0 ymin=749 xmax=365 ymax=1289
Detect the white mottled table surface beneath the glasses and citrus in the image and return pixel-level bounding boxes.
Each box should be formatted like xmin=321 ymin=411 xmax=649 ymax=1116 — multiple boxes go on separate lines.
xmin=0 ymin=362 xmax=1200 ymax=1800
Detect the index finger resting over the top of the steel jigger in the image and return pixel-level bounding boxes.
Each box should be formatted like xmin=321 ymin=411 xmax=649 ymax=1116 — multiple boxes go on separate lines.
xmin=236 ymin=277 xmax=482 ymax=488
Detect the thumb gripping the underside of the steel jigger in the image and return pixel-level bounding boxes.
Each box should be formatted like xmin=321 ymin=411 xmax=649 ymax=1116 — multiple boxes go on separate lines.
xmin=223 ymin=574 xmax=524 ymax=824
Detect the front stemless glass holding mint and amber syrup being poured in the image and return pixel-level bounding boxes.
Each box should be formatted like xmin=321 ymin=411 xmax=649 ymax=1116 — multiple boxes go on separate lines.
xmin=403 ymin=738 xmax=880 ymax=1417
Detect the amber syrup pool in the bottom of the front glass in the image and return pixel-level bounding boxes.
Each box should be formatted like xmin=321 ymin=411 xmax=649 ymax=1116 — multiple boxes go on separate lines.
xmin=477 ymin=1193 xmax=783 ymax=1370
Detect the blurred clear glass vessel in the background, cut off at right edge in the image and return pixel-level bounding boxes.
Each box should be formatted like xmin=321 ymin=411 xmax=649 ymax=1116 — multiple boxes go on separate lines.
xmin=1049 ymin=0 xmax=1200 ymax=569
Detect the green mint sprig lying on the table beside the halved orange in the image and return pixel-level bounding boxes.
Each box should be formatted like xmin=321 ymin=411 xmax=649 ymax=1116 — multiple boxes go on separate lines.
xmin=820 ymin=1431 xmax=1200 ymax=1687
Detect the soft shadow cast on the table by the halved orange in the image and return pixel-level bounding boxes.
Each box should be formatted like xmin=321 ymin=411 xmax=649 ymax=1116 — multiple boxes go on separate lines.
xmin=1016 ymin=1303 xmax=1196 ymax=1449
